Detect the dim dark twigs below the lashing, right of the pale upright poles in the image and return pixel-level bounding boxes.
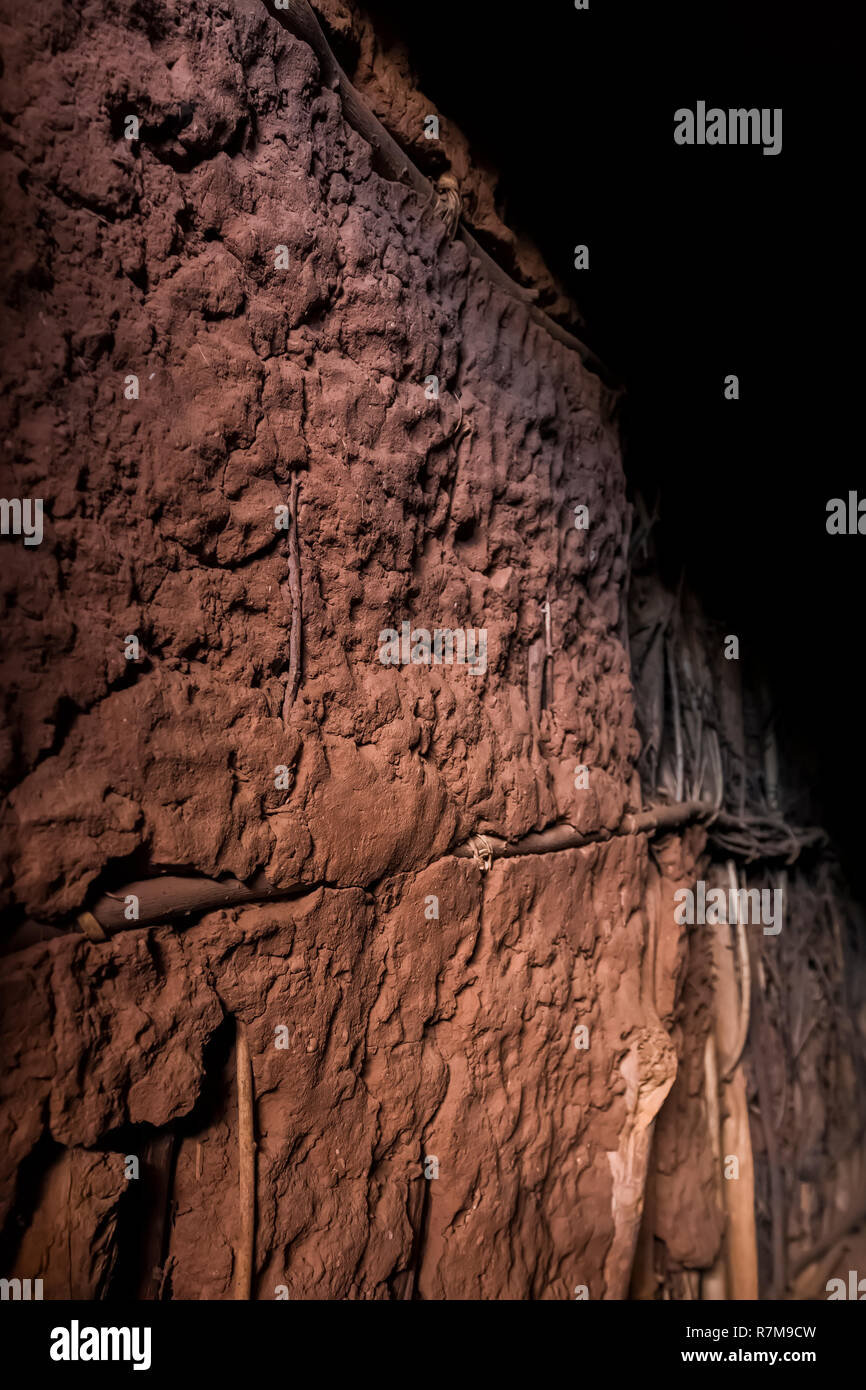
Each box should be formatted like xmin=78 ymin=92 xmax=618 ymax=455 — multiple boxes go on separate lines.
xmin=748 ymin=862 xmax=866 ymax=1297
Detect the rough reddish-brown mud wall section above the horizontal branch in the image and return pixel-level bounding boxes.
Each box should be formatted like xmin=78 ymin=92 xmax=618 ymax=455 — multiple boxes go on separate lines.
xmin=3 ymin=3 xmax=635 ymax=919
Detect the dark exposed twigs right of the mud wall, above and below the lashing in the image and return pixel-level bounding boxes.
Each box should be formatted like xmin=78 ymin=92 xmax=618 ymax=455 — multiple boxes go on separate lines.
xmin=628 ymin=498 xmax=866 ymax=1297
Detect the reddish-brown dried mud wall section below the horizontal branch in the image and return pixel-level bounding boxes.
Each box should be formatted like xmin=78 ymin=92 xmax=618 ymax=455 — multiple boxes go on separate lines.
xmin=3 ymin=837 xmax=706 ymax=1298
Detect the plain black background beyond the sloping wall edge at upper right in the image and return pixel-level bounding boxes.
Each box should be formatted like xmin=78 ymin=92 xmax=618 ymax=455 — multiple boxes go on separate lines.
xmin=370 ymin=0 xmax=866 ymax=891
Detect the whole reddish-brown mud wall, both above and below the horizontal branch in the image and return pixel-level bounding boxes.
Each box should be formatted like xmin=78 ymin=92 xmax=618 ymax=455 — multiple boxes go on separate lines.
xmin=0 ymin=0 xmax=717 ymax=1298
